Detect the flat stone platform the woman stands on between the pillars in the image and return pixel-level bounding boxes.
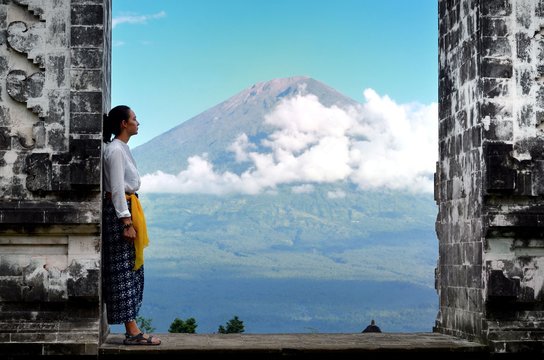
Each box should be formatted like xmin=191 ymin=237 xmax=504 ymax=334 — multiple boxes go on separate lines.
xmin=99 ymin=333 xmax=490 ymax=360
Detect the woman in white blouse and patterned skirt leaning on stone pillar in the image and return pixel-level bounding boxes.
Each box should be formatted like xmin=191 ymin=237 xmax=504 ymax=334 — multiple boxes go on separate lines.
xmin=102 ymin=105 xmax=161 ymax=345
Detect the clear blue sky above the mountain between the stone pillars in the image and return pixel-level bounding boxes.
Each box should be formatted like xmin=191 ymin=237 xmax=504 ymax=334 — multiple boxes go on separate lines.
xmin=112 ymin=0 xmax=438 ymax=147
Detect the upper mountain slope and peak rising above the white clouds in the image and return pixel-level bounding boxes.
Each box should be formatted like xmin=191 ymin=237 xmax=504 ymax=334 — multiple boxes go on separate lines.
xmin=133 ymin=76 xmax=357 ymax=174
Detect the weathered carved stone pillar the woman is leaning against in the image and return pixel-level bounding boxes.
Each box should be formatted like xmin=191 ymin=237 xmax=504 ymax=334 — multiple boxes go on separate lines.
xmin=0 ymin=0 xmax=111 ymax=355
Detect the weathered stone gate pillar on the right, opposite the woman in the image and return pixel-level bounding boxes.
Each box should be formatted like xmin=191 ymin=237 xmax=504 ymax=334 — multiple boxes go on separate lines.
xmin=435 ymin=0 xmax=544 ymax=353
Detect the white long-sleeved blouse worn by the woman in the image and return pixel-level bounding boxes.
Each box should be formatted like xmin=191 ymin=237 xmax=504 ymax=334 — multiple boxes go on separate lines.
xmin=103 ymin=139 xmax=140 ymax=218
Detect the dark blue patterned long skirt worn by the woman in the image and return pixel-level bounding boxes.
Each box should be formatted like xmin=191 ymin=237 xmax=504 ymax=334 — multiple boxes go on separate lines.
xmin=102 ymin=198 xmax=144 ymax=324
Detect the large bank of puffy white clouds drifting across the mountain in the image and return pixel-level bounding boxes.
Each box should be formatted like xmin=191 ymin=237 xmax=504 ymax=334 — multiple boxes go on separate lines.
xmin=141 ymin=89 xmax=438 ymax=198
